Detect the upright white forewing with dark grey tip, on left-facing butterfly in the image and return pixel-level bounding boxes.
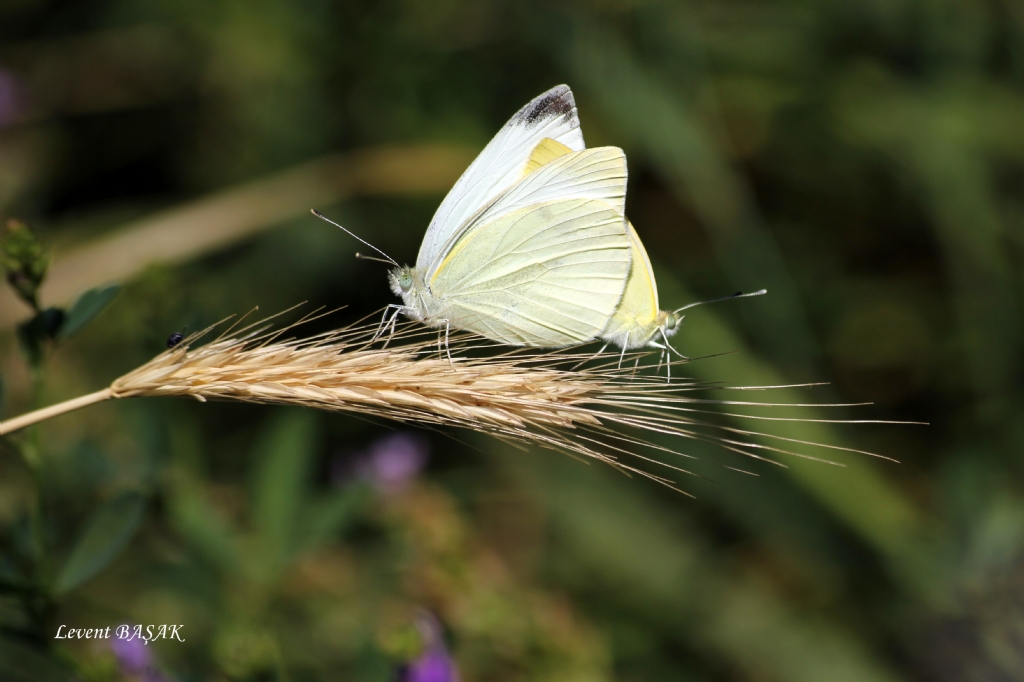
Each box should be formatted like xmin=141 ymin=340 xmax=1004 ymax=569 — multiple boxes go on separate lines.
xmin=416 ymin=85 xmax=586 ymax=269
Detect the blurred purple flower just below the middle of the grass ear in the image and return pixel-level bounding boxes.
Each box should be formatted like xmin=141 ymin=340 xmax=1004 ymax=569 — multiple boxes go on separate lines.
xmin=331 ymin=433 xmax=429 ymax=496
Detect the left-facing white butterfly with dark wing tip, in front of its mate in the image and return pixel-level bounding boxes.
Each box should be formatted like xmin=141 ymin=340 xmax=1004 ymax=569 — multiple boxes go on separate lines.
xmin=390 ymin=85 xmax=631 ymax=346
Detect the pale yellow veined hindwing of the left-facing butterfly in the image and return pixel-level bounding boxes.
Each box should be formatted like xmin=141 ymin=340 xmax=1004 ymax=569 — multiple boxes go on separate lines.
xmin=431 ymin=199 xmax=630 ymax=347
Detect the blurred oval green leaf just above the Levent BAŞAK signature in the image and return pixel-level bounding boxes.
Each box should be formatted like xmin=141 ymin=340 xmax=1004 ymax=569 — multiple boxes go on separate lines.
xmin=53 ymin=485 xmax=145 ymax=594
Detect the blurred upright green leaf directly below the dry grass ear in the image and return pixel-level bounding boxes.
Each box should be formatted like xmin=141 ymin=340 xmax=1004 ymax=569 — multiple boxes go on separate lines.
xmin=251 ymin=410 xmax=315 ymax=574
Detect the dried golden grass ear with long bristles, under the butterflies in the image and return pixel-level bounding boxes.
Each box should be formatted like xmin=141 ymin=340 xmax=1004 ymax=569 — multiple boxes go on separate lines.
xmin=0 ymin=307 xmax=897 ymax=483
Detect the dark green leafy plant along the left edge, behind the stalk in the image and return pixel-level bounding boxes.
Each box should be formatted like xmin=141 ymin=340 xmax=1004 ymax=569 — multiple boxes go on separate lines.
xmin=0 ymin=219 xmax=124 ymax=680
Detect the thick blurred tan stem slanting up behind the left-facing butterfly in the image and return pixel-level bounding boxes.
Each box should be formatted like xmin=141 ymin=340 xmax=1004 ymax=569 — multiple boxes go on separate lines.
xmin=0 ymin=145 xmax=475 ymax=330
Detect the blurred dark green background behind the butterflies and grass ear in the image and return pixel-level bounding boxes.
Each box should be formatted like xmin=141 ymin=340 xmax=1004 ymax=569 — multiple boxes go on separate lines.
xmin=0 ymin=0 xmax=1024 ymax=682
